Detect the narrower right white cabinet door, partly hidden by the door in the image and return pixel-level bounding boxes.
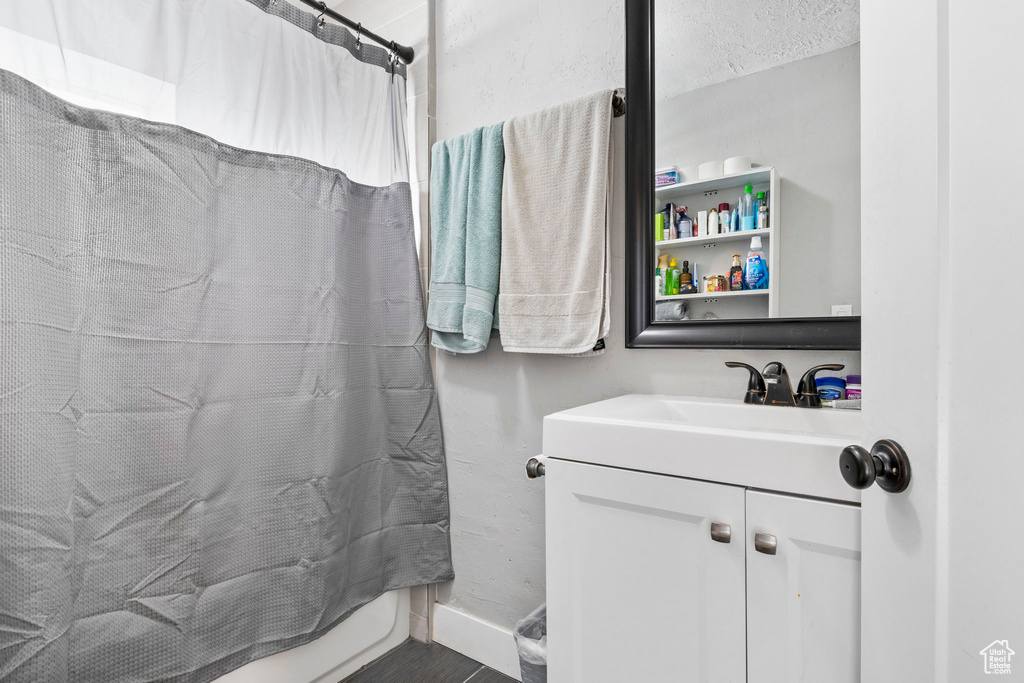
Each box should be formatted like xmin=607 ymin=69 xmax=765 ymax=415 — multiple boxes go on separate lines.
xmin=746 ymin=490 xmax=860 ymax=683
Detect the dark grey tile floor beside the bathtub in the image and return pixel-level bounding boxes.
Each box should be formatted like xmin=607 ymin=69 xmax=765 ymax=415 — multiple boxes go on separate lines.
xmin=341 ymin=640 xmax=515 ymax=683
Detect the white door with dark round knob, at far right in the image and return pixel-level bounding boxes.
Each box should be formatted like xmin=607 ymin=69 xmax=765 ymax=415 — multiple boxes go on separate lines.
xmin=861 ymin=0 xmax=1024 ymax=683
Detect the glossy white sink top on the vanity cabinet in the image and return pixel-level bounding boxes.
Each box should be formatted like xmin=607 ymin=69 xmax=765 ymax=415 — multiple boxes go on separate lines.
xmin=544 ymin=394 xmax=861 ymax=502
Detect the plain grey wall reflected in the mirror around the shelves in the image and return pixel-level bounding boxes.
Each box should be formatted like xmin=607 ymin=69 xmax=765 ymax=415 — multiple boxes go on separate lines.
xmin=654 ymin=44 xmax=860 ymax=317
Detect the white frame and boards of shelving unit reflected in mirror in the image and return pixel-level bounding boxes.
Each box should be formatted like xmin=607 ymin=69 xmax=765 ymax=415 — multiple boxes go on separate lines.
xmin=651 ymin=166 xmax=781 ymax=317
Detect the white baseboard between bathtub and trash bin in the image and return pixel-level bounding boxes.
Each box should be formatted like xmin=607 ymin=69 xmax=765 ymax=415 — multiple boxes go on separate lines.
xmin=434 ymin=603 xmax=522 ymax=681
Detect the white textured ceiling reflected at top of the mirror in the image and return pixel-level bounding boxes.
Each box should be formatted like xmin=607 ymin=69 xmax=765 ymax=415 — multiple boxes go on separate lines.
xmin=654 ymin=0 xmax=860 ymax=99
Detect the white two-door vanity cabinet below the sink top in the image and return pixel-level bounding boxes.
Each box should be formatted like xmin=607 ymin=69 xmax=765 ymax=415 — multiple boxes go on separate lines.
xmin=545 ymin=458 xmax=860 ymax=683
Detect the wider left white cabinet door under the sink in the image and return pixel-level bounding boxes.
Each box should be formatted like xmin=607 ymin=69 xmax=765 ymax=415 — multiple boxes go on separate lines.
xmin=545 ymin=460 xmax=745 ymax=683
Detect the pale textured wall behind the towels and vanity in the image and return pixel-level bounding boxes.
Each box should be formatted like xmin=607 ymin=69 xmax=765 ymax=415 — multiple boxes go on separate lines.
xmin=435 ymin=0 xmax=859 ymax=629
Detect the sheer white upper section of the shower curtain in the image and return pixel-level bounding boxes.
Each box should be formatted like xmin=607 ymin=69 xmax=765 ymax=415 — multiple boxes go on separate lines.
xmin=0 ymin=0 xmax=409 ymax=186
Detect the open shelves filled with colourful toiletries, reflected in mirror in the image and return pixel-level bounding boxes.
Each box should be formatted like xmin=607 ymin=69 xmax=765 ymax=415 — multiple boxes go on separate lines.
xmin=653 ymin=167 xmax=780 ymax=319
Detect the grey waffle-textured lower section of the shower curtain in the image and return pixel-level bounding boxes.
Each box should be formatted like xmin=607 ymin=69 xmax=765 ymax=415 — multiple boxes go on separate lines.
xmin=0 ymin=58 xmax=453 ymax=683
